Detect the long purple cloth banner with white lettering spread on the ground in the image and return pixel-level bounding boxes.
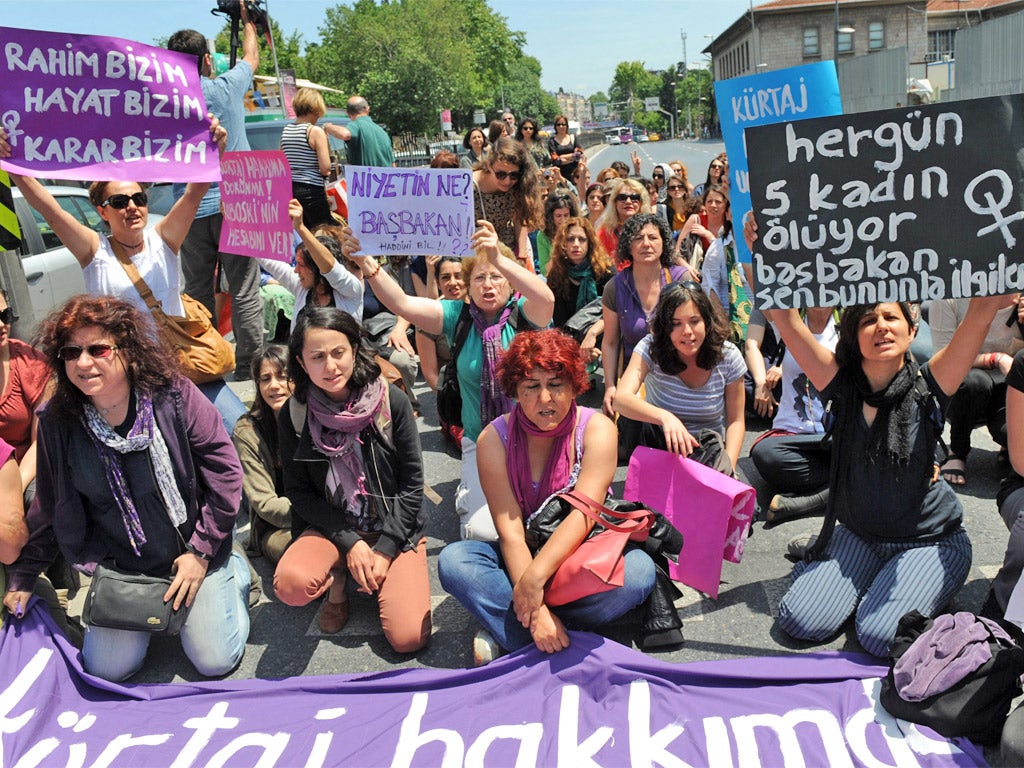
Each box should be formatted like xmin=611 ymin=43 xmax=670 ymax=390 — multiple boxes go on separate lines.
xmin=0 ymin=601 xmax=984 ymax=768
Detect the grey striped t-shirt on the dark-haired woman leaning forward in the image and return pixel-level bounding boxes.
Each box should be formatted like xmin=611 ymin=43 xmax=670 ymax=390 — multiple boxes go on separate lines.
xmin=634 ymin=334 xmax=746 ymax=437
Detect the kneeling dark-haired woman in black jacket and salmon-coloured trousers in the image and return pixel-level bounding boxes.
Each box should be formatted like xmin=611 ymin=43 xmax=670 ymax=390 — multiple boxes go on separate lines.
xmin=273 ymin=307 xmax=430 ymax=653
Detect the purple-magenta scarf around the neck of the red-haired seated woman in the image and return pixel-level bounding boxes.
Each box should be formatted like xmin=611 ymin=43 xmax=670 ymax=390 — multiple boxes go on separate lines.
xmin=505 ymin=400 xmax=577 ymax=519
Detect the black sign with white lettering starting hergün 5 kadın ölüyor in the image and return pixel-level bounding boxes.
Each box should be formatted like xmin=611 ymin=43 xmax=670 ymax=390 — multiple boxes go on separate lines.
xmin=745 ymin=94 xmax=1024 ymax=309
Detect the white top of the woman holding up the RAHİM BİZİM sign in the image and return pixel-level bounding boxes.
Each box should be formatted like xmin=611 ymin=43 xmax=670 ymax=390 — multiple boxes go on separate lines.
xmin=83 ymin=229 xmax=185 ymax=317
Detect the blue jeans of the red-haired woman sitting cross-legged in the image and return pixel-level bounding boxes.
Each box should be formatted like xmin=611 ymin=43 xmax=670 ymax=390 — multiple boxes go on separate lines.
xmin=437 ymin=540 xmax=654 ymax=650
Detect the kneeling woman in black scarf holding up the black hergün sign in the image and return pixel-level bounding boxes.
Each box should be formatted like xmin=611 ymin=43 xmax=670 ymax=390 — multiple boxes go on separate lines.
xmin=746 ymin=215 xmax=1006 ymax=656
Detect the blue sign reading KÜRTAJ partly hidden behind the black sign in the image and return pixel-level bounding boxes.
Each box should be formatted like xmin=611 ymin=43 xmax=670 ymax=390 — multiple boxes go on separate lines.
xmin=715 ymin=61 xmax=843 ymax=263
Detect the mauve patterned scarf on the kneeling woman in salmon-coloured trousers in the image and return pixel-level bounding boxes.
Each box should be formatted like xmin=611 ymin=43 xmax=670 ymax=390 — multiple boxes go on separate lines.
xmin=306 ymin=378 xmax=385 ymax=517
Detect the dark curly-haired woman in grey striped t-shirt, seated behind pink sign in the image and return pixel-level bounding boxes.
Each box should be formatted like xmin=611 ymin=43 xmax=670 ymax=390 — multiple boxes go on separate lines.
xmin=612 ymin=281 xmax=746 ymax=471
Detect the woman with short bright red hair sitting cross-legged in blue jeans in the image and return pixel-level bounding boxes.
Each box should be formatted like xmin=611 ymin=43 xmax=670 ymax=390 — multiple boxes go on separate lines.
xmin=438 ymin=331 xmax=655 ymax=665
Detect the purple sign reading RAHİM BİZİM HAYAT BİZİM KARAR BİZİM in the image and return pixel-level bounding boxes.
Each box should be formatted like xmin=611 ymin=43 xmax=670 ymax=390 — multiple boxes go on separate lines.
xmin=0 ymin=28 xmax=220 ymax=181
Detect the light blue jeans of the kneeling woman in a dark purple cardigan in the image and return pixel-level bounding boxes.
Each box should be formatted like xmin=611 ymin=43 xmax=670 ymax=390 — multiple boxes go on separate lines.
xmin=82 ymin=545 xmax=249 ymax=682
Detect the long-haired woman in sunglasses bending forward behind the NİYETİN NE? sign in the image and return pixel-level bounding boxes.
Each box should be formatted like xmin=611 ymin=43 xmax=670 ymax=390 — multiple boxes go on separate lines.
xmin=473 ymin=136 xmax=543 ymax=271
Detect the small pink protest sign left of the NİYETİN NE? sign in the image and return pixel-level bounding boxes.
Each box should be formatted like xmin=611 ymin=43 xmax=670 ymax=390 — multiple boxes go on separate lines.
xmin=220 ymin=150 xmax=292 ymax=263
